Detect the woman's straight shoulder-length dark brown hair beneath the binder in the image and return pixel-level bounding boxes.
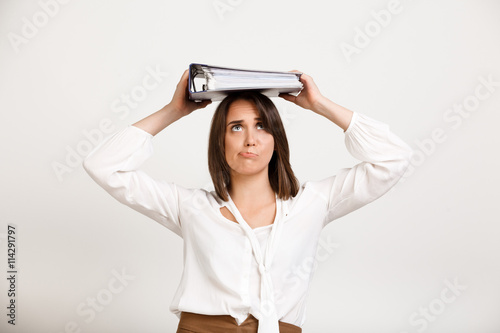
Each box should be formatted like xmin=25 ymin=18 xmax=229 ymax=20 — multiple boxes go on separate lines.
xmin=208 ymin=91 xmax=299 ymax=201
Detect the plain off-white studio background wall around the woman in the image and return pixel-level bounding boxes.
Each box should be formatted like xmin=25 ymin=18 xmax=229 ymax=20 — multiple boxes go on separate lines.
xmin=0 ymin=0 xmax=500 ymax=333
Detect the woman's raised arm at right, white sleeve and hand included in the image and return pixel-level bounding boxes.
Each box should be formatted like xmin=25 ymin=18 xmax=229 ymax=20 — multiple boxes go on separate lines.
xmin=280 ymin=70 xmax=412 ymax=226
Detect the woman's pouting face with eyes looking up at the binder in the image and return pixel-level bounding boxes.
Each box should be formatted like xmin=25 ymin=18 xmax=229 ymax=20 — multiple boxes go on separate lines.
xmin=225 ymin=100 xmax=274 ymax=175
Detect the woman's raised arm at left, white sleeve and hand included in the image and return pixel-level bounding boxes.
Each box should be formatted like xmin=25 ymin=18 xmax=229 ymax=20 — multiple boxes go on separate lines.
xmin=83 ymin=71 xmax=210 ymax=237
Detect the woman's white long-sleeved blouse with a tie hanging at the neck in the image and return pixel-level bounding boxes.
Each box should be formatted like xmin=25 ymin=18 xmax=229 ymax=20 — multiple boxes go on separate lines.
xmin=83 ymin=112 xmax=412 ymax=333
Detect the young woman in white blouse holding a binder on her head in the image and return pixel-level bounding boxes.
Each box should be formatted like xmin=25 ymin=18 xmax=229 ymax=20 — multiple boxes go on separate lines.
xmin=83 ymin=71 xmax=412 ymax=333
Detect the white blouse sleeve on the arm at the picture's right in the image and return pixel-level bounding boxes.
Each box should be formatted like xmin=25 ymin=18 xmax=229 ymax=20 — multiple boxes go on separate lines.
xmin=310 ymin=112 xmax=413 ymax=226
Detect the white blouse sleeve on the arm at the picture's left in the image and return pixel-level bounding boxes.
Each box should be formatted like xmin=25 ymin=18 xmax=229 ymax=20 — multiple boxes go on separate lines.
xmin=83 ymin=125 xmax=182 ymax=237
